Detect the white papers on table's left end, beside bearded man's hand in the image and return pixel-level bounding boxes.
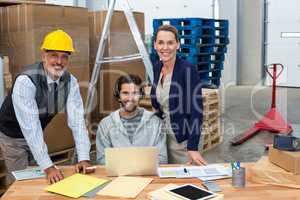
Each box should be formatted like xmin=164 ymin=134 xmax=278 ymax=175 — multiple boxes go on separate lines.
xmin=12 ymin=167 xmax=46 ymax=181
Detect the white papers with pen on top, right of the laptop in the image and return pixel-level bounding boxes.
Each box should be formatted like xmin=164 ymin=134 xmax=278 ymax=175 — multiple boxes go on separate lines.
xmin=158 ymin=164 xmax=231 ymax=180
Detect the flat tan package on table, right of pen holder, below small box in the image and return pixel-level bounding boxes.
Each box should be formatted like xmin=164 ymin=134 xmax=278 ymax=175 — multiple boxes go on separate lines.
xmin=247 ymin=156 xmax=300 ymax=189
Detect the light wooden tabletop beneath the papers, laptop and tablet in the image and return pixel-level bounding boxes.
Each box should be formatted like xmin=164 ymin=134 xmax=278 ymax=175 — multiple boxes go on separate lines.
xmin=2 ymin=163 xmax=300 ymax=200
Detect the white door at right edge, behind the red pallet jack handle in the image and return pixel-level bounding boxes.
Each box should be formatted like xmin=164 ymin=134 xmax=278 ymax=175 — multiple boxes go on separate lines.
xmin=265 ymin=0 xmax=300 ymax=87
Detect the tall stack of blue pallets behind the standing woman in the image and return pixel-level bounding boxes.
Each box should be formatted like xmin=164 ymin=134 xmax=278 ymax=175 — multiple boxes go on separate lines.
xmin=152 ymin=18 xmax=229 ymax=88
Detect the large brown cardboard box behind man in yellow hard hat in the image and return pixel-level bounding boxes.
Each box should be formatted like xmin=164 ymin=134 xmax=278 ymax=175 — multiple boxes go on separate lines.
xmin=0 ymin=4 xmax=89 ymax=85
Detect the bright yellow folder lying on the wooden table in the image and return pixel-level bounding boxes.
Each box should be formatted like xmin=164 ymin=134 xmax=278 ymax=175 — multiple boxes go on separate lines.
xmin=45 ymin=174 xmax=107 ymax=198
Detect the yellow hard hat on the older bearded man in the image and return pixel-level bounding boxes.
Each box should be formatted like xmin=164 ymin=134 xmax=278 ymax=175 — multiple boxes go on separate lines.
xmin=41 ymin=29 xmax=75 ymax=52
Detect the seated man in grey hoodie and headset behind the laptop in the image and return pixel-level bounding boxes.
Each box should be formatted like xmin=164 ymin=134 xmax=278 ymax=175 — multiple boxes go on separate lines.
xmin=96 ymin=74 xmax=168 ymax=164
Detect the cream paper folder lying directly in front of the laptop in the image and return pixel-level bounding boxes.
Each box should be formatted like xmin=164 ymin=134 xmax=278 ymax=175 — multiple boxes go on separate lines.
xmin=97 ymin=176 xmax=152 ymax=198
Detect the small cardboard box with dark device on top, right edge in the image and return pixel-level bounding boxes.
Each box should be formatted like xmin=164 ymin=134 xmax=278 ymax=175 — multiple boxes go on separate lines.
xmin=269 ymin=147 xmax=300 ymax=175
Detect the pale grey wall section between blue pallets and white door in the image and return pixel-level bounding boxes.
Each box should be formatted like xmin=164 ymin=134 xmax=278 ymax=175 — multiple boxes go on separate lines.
xmin=237 ymin=0 xmax=264 ymax=85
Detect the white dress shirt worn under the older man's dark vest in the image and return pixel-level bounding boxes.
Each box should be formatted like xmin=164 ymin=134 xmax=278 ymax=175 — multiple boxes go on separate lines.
xmin=12 ymin=75 xmax=91 ymax=170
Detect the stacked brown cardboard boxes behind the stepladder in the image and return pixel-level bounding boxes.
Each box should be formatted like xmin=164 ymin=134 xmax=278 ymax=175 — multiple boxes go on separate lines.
xmin=89 ymin=11 xmax=145 ymax=127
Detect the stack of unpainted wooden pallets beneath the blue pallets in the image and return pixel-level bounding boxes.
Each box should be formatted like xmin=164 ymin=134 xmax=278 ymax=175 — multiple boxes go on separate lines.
xmin=200 ymin=89 xmax=222 ymax=152
